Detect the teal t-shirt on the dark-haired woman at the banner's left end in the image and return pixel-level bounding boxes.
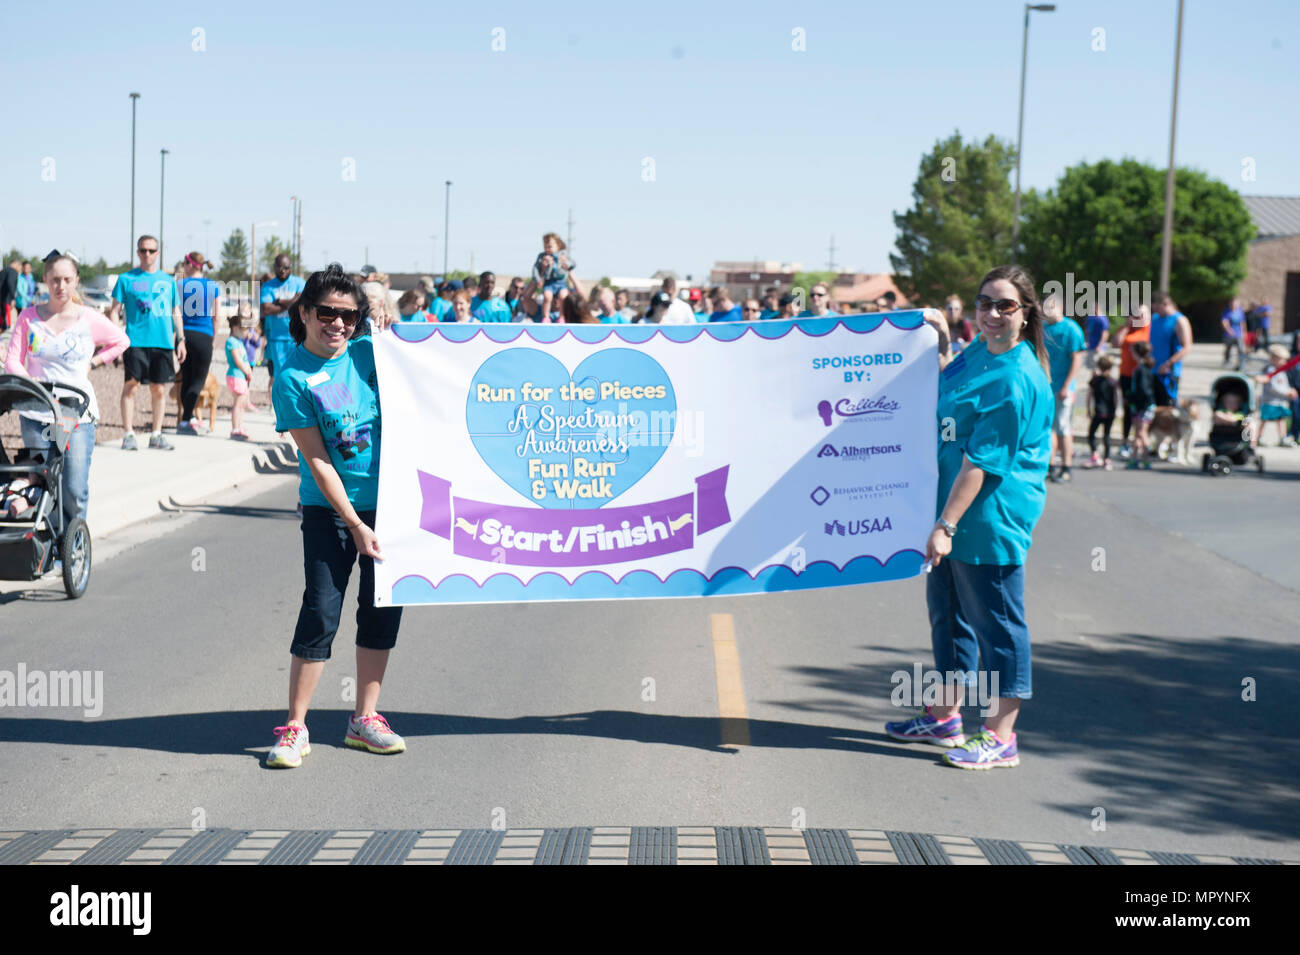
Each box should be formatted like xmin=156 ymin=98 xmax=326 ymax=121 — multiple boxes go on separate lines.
xmin=272 ymin=337 xmax=380 ymax=511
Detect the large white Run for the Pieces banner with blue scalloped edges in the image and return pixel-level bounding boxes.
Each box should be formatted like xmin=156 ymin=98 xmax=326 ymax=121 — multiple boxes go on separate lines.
xmin=374 ymin=312 xmax=939 ymax=605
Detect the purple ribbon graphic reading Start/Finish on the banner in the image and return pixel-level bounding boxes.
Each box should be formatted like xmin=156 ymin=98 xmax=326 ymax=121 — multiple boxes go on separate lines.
xmin=416 ymin=465 xmax=731 ymax=567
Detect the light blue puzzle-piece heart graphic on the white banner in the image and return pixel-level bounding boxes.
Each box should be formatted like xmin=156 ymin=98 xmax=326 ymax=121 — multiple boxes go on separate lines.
xmin=465 ymin=348 xmax=677 ymax=509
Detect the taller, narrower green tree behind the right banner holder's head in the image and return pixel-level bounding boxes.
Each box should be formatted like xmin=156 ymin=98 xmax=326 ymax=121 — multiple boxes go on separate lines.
xmin=889 ymin=131 xmax=1015 ymax=305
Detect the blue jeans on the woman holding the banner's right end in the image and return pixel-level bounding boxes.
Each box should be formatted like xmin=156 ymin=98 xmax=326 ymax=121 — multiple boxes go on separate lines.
xmin=926 ymin=557 xmax=1034 ymax=699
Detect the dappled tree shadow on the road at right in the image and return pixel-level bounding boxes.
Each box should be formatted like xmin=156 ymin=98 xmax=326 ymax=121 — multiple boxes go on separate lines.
xmin=768 ymin=633 xmax=1300 ymax=838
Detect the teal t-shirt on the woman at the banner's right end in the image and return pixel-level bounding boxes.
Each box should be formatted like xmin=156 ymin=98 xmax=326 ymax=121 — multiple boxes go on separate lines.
xmin=935 ymin=340 xmax=1056 ymax=567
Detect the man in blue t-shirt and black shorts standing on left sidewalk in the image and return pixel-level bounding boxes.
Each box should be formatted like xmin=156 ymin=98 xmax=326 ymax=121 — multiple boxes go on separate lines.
xmin=109 ymin=235 xmax=186 ymax=451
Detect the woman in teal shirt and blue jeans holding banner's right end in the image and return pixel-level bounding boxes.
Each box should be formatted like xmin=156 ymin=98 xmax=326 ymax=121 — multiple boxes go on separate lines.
xmin=885 ymin=265 xmax=1054 ymax=769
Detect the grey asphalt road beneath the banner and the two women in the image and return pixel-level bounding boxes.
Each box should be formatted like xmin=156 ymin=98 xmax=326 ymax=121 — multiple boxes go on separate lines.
xmin=0 ymin=470 xmax=1300 ymax=859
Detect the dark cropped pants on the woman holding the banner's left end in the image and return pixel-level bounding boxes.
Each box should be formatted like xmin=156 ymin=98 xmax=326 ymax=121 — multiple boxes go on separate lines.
xmin=289 ymin=504 xmax=402 ymax=660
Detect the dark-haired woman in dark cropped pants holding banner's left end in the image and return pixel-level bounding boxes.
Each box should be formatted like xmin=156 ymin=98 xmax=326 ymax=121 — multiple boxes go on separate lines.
xmin=267 ymin=262 xmax=406 ymax=768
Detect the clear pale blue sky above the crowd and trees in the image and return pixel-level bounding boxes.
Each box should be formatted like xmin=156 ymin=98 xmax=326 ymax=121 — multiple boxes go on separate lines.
xmin=0 ymin=0 xmax=1300 ymax=278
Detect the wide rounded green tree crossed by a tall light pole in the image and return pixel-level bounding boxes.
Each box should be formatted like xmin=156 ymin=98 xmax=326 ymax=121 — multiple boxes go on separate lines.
xmin=1021 ymin=159 xmax=1255 ymax=303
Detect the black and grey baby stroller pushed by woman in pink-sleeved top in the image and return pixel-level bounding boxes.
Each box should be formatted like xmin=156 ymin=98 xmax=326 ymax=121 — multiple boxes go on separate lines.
xmin=0 ymin=374 xmax=90 ymax=599
